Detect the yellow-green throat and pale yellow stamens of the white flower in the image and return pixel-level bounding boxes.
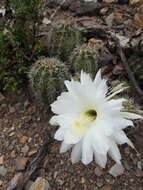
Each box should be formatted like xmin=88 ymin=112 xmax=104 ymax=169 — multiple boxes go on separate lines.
xmin=73 ymin=109 xmax=97 ymax=133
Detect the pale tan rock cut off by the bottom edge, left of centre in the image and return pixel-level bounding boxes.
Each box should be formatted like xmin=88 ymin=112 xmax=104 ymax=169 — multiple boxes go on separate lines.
xmin=29 ymin=177 xmax=49 ymax=190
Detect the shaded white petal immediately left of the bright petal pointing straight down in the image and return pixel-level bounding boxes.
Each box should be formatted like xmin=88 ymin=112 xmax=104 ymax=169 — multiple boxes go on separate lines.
xmin=71 ymin=142 xmax=82 ymax=163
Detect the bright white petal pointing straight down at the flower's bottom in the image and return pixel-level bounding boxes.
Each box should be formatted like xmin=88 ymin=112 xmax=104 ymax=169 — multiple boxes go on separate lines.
xmin=82 ymin=137 xmax=93 ymax=165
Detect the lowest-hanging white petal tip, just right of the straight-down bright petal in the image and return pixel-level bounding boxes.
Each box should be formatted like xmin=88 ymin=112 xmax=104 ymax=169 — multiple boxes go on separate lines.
xmin=94 ymin=152 xmax=107 ymax=168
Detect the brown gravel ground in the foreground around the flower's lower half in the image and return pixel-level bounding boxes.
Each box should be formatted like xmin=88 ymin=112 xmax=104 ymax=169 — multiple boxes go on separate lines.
xmin=0 ymin=87 xmax=143 ymax=190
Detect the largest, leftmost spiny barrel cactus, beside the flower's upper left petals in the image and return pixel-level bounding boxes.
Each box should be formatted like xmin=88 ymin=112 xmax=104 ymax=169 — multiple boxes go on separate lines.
xmin=29 ymin=58 xmax=69 ymax=108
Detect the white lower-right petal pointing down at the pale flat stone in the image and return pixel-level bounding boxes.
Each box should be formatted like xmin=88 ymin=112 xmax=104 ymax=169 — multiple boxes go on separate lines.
xmin=108 ymin=142 xmax=121 ymax=164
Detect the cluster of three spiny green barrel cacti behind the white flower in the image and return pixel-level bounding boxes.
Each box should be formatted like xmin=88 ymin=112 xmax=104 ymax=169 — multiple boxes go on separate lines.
xmin=29 ymin=24 xmax=99 ymax=109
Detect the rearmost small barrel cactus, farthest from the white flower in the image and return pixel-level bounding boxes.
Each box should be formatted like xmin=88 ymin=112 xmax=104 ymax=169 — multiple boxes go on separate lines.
xmin=48 ymin=24 xmax=81 ymax=61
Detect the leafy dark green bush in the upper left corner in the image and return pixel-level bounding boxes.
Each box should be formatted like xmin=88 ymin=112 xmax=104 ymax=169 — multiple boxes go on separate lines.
xmin=0 ymin=0 xmax=44 ymax=90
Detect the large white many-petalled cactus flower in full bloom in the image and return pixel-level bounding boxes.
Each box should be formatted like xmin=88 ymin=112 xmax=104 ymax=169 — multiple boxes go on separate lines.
xmin=50 ymin=70 xmax=143 ymax=168
